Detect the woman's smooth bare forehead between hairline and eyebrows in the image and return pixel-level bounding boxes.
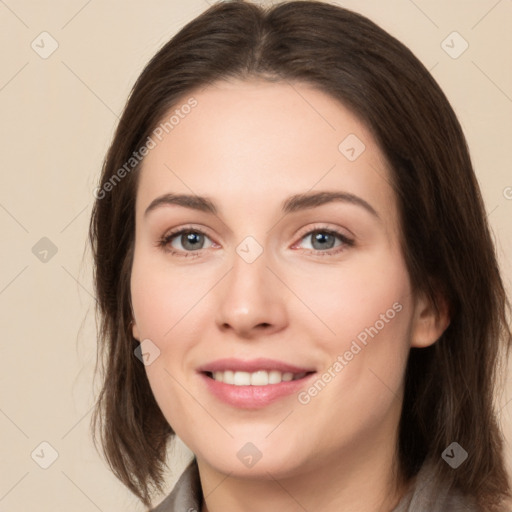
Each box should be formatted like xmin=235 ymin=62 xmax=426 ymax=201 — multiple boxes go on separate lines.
xmin=134 ymin=80 xmax=390 ymax=219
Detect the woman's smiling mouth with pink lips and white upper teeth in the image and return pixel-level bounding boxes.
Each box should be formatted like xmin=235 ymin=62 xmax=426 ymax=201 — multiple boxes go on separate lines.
xmin=198 ymin=358 xmax=315 ymax=409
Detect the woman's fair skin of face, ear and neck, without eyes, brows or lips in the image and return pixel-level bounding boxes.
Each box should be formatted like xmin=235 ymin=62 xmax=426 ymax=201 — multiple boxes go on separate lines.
xmin=131 ymin=79 xmax=449 ymax=512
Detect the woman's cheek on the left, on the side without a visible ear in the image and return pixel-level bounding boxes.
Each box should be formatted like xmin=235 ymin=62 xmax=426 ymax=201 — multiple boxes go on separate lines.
xmin=131 ymin=251 xmax=218 ymax=432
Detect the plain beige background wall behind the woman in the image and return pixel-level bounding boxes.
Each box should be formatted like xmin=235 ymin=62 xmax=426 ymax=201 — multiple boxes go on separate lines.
xmin=0 ymin=0 xmax=512 ymax=512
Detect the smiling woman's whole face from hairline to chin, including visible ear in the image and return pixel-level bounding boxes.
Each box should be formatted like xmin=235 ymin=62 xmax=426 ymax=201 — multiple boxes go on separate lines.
xmin=131 ymin=81 xmax=440 ymax=477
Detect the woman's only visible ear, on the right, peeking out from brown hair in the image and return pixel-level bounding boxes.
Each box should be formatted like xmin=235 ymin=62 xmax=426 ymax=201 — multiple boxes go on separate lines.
xmin=411 ymin=292 xmax=450 ymax=348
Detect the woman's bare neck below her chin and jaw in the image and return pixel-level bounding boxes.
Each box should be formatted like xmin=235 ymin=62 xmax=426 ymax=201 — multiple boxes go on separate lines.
xmin=198 ymin=436 xmax=407 ymax=512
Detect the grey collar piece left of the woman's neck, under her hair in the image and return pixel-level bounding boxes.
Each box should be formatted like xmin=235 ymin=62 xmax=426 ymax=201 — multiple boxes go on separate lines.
xmin=150 ymin=459 xmax=203 ymax=512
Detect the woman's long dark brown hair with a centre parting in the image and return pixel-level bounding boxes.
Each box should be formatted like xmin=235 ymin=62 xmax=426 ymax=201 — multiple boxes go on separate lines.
xmin=89 ymin=1 xmax=512 ymax=511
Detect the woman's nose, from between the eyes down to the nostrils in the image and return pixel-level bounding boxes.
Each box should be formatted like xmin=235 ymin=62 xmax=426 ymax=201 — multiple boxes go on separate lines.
xmin=216 ymin=248 xmax=288 ymax=339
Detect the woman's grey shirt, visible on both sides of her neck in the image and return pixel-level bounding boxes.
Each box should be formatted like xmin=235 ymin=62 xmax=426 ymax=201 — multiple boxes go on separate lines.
xmin=152 ymin=459 xmax=479 ymax=512
